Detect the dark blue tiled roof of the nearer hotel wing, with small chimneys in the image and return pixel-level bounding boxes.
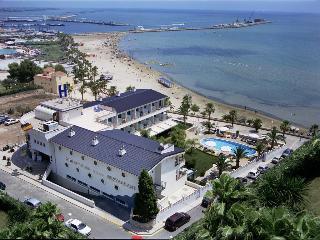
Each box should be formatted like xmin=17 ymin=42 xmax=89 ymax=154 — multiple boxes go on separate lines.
xmin=51 ymin=126 xmax=183 ymax=176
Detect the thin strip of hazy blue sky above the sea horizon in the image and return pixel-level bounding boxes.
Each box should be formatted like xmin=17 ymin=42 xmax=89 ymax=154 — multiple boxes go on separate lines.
xmin=0 ymin=0 xmax=320 ymax=13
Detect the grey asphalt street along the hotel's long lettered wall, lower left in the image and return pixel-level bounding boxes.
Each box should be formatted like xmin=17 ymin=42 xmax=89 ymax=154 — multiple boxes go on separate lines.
xmin=0 ymin=170 xmax=131 ymax=239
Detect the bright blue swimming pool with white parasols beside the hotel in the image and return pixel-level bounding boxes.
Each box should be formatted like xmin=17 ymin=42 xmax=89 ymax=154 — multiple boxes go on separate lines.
xmin=200 ymin=138 xmax=256 ymax=157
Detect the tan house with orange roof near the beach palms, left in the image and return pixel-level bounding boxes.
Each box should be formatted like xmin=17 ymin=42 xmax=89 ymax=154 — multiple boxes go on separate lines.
xmin=33 ymin=67 xmax=74 ymax=94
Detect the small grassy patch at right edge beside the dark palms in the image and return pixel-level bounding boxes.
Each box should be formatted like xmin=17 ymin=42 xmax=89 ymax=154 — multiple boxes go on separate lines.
xmin=306 ymin=177 xmax=320 ymax=216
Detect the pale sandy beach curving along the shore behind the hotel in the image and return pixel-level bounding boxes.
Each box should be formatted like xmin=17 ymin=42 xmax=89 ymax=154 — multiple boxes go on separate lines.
xmin=73 ymin=33 xmax=280 ymax=127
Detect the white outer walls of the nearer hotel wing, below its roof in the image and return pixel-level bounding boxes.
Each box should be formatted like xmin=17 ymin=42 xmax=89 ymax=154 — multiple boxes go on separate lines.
xmin=51 ymin=143 xmax=187 ymax=207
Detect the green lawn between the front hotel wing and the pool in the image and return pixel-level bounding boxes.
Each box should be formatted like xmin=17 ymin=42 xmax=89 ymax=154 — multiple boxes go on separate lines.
xmin=184 ymin=149 xmax=217 ymax=177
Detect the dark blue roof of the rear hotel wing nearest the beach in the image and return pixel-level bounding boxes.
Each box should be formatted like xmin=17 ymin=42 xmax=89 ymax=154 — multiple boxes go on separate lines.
xmin=83 ymin=89 xmax=167 ymax=113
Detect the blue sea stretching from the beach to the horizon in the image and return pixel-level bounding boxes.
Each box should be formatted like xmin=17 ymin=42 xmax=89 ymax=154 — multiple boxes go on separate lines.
xmin=0 ymin=7 xmax=320 ymax=127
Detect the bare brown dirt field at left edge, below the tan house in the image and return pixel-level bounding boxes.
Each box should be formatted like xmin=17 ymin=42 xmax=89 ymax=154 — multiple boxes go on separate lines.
xmin=0 ymin=90 xmax=57 ymax=118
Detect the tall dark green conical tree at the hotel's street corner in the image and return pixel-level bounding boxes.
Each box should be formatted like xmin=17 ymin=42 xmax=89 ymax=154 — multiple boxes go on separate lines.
xmin=133 ymin=170 xmax=159 ymax=222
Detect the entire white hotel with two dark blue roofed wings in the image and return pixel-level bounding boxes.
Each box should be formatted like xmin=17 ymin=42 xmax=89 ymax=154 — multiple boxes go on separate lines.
xmin=22 ymin=90 xmax=187 ymax=207
